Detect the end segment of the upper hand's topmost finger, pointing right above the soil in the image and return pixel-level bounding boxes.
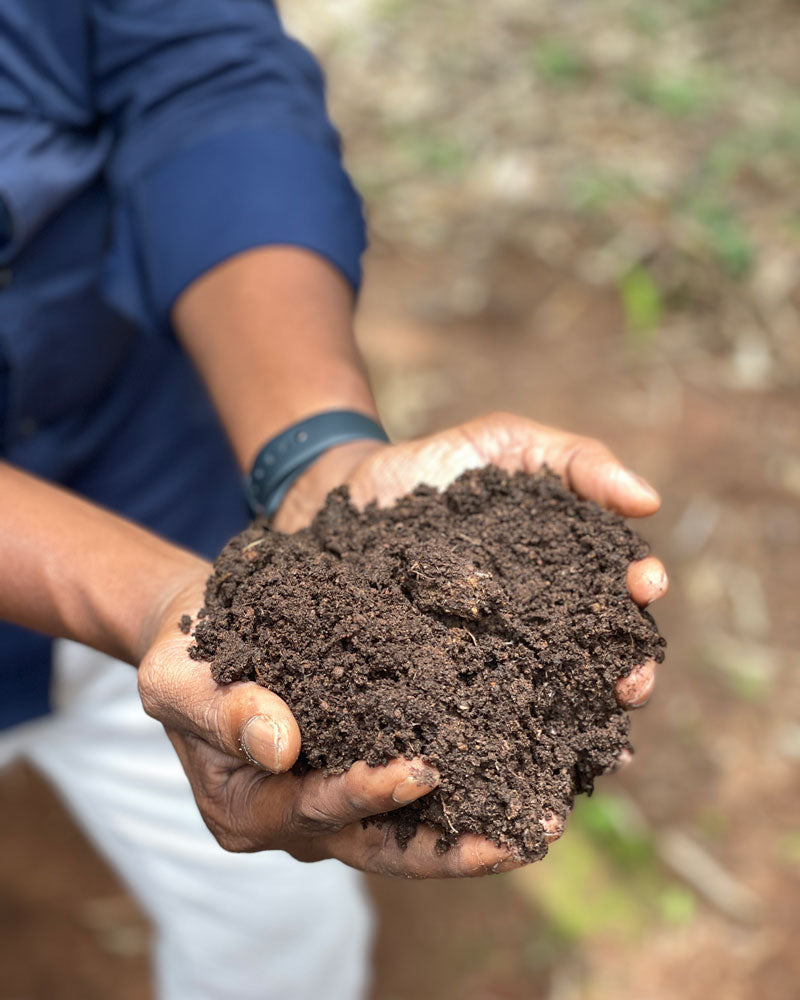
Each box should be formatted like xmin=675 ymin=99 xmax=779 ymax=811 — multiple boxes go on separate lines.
xmin=555 ymin=438 xmax=661 ymax=517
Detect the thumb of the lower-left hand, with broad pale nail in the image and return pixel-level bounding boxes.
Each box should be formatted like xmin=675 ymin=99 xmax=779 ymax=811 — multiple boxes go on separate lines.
xmin=139 ymin=636 xmax=300 ymax=773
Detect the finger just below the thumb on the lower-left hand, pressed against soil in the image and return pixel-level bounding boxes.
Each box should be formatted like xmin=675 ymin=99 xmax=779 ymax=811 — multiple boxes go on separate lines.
xmin=295 ymin=759 xmax=439 ymax=833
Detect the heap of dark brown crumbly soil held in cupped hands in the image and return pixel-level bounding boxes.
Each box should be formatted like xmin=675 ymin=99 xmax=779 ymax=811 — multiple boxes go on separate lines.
xmin=190 ymin=466 xmax=665 ymax=860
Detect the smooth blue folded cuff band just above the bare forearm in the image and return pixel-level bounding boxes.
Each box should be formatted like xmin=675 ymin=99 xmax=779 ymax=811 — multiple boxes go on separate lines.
xmin=104 ymin=129 xmax=366 ymax=330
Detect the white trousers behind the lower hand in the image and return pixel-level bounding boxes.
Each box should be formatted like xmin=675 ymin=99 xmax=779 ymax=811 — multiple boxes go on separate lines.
xmin=0 ymin=641 xmax=371 ymax=1000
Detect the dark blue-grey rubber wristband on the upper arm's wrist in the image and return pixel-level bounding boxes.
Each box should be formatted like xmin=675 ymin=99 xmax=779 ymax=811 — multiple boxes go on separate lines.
xmin=244 ymin=410 xmax=389 ymax=517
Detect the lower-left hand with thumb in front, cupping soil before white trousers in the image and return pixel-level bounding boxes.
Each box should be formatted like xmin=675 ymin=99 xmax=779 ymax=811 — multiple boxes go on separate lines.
xmin=139 ymin=580 xmax=517 ymax=878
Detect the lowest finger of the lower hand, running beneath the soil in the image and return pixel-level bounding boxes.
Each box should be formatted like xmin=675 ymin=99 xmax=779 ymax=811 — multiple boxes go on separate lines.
xmin=325 ymin=823 xmax=523 ymax=879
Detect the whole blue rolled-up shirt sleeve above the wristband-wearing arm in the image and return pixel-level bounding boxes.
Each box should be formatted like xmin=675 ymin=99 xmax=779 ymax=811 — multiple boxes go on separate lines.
xmin=92 ymin=0 xmax=365 ymax=330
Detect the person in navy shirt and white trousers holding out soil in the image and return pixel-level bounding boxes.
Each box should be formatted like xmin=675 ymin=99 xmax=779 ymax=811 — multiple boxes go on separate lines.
xmin=0 ymin=0 xmax=666 ymax=1000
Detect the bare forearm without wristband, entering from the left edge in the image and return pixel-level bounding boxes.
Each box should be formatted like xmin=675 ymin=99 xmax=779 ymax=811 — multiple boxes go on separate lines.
xmin=0 ymin=463 xmax=208 ymax=664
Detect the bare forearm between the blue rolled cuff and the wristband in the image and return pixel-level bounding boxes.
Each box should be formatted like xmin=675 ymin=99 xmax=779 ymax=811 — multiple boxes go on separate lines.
xmin=173 ymin=247 xmax=376 ymax=470
